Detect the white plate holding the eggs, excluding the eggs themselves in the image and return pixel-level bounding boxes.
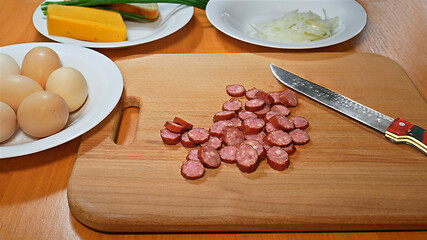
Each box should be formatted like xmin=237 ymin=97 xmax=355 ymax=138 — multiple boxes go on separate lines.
xmin=0 ymin=43 xmax=123 ymax=159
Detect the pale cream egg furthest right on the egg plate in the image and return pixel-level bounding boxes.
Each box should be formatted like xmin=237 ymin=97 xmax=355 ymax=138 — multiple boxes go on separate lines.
xmin=46 ymin=67 xmax=88 ymax=112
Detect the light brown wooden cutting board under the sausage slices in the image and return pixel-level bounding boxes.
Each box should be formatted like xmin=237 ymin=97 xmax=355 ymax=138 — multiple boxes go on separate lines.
xmin=68 ymin=53 xmax=427 ymax=232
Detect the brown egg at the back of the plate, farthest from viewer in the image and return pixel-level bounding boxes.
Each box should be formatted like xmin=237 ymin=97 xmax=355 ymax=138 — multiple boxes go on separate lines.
xmin=21 ymin=47 xmax=62 ymax=88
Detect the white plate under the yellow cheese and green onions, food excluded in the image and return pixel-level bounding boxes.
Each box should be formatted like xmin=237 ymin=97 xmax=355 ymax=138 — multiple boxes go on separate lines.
xmin=33 ymin=3 xmax=194 ymax=48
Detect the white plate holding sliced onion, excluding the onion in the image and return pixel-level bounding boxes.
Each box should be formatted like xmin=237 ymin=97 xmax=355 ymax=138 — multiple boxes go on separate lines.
xmin=206 ymin=0 xmax=367 ymax=49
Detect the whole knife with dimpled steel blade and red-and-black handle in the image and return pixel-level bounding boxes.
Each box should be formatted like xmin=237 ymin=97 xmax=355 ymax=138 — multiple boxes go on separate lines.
xmin=270 ymin=64 xmax=427 ymax=155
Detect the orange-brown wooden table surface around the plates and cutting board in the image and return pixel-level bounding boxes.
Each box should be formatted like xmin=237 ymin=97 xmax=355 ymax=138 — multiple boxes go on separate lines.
xmin=0 ymin=0 xmax=427 ymax=239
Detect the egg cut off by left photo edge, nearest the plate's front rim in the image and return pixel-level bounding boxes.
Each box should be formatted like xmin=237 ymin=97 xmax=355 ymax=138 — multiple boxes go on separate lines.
xmin=0 ymin=102 xmax=16 ymax=142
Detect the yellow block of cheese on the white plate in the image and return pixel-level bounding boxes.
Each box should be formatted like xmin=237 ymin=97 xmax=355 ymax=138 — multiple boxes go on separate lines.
xmin=47 ymin=4 xmax=127 ymax=42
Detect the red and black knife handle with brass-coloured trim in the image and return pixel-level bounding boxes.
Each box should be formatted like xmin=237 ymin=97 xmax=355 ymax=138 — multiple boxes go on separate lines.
xmin=385 ymin=118 xmax=427 ymax=155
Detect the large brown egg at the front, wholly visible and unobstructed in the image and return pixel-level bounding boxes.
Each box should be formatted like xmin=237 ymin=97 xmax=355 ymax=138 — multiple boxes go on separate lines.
xmin=17 ymin=91 xmax=69 ymax=138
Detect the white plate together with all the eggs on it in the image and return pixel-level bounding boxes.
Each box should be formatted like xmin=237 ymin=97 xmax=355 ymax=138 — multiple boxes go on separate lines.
xmin=0 ymin=43 xmax=123 ymax=159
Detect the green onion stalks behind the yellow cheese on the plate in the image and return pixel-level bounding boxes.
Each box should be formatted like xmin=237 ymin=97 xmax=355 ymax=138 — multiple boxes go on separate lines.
xmin=40 ymin=0 xmax=209 ymax=18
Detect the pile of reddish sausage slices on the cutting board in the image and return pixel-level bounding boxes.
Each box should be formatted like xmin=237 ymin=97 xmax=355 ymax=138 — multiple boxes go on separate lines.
xmin=160 ymin=84 xmax=310 ymax=180
